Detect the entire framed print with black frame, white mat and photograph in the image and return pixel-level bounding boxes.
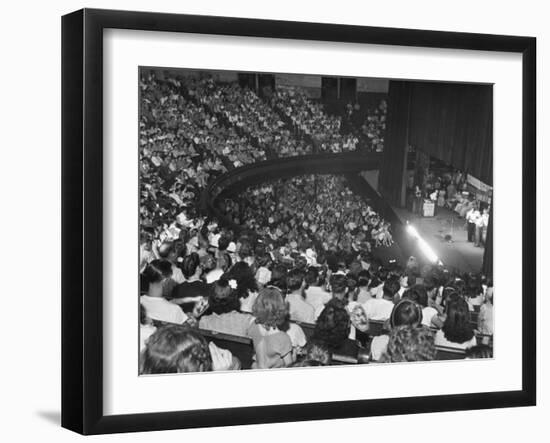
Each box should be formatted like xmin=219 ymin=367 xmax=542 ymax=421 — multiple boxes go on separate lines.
xmin=62 ymin=9 xmax=536 ymax=434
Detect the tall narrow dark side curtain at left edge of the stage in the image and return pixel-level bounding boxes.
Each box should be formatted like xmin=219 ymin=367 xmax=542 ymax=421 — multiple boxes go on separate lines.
xmin=378 ymin=81 xmax=411 ymax=206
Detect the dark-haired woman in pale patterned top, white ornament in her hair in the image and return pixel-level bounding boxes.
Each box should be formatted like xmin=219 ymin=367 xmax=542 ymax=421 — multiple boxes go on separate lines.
xmin=199 ymin=277 xmax=254 ymax=337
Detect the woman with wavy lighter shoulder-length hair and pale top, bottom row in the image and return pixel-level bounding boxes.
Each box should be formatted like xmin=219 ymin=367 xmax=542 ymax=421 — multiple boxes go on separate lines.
xmin=247 ymin=288 xmax=296 ymax=369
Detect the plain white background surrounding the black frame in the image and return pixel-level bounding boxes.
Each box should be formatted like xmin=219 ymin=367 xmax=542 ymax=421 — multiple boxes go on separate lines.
xmin=0 ymin=0 xmax=550 ymax=443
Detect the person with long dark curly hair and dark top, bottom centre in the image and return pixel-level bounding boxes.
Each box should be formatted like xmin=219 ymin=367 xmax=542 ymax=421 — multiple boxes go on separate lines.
xmin=312 ymin=299 xmax=360 ymax=358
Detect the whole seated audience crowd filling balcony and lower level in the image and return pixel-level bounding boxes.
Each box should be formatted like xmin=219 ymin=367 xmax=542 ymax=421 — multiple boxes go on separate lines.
xmin=140 ymin=73 xmax=493 ymax=374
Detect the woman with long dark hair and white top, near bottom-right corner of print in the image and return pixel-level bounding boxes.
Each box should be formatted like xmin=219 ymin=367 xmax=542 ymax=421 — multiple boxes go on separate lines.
xmin=435 ymin=295 xmax=477 ymax=349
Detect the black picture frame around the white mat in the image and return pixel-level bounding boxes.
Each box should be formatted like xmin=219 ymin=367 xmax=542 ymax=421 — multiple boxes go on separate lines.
xmin=62 ymin=9 xmax=536 ymax=434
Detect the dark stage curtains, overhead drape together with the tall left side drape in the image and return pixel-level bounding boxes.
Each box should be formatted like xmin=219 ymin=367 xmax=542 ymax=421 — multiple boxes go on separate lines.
xmin=380 ymin=80 xmax=493 ymax=205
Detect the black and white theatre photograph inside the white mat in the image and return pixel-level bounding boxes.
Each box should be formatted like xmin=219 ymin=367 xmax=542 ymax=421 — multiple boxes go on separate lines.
xmin=136 ymin=66 xmax=498 ymax=377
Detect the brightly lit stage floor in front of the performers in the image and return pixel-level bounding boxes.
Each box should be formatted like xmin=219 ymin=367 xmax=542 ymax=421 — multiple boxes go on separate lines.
xmin=393 ymin=207 xmax=484 ymax=272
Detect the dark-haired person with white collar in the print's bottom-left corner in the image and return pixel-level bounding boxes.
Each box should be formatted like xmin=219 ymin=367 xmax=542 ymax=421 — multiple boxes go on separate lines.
xmin=140 ymin=325 xmax=234 ymax=374
